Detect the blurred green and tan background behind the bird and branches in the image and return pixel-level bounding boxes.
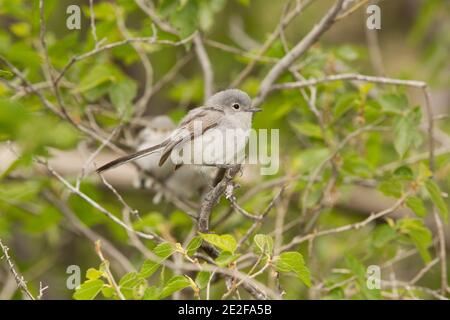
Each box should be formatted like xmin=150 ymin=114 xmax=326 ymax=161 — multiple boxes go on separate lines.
xmin=0 ymin=0 xmax=450 ymax=299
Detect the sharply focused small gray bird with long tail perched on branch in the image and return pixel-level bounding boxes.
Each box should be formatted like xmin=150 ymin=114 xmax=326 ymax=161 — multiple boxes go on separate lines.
xmin=97 ymin=89 xmax=261 ymax=173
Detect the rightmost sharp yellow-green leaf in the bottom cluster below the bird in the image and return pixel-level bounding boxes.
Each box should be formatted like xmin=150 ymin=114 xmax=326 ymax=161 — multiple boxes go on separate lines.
xmin=275 ymin=252 xmax=311 ymax=287
